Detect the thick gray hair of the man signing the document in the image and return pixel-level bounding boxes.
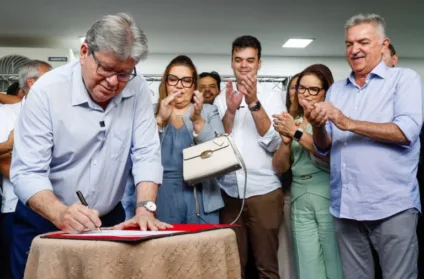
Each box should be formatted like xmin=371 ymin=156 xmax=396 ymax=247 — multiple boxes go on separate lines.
xmin=85 ymin=13 xmax=148 ymax=62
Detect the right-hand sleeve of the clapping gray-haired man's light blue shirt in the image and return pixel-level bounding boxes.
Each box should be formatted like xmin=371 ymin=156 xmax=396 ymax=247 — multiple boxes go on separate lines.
xmin=393 ymin=70 xmax=423 ymax=146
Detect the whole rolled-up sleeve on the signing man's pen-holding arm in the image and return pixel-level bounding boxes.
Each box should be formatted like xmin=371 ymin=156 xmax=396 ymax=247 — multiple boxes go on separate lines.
xmin=10 ymin=86 xmax=53 ymax=204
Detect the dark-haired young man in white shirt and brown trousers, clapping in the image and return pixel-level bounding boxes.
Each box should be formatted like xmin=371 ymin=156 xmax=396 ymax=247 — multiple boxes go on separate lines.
xmin=215 ymin=36 xmax=286 ymax=278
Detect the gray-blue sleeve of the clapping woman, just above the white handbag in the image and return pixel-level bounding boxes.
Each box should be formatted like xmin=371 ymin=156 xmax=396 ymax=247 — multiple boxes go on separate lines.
xmin=194 ymin=105 xmax=224 ymax=143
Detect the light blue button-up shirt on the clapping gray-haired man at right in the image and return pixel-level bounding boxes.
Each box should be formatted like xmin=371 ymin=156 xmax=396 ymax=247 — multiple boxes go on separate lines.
xmin=320 ymin=62 xmax=423 ymax=220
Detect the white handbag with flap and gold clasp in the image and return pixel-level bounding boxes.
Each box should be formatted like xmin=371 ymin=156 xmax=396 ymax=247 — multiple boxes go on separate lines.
xmin=183 ymin=134 xmax=244 ymax=185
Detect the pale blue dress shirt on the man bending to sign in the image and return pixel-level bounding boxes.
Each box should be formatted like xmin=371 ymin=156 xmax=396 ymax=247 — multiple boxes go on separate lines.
xmin=11 ymin=62 xmax=163 ymax=215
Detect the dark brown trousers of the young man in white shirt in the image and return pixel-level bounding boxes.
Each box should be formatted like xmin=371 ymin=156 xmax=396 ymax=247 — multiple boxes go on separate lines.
xmin=220 ymin=188 xmax=284 ymax=279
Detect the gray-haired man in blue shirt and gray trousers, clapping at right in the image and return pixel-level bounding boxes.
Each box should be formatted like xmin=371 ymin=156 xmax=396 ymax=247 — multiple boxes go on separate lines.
xmin=306 ymin=14 xmax=423 ymax=279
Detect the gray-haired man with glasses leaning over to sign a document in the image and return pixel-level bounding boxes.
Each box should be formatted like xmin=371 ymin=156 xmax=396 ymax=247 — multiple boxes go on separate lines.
xmin=10 ymin=13 xmax=170 ymax=278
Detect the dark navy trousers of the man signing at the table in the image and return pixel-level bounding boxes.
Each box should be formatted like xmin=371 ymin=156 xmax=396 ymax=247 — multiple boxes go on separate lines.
xmin=11 ymin=201 xmax=125 ymax=279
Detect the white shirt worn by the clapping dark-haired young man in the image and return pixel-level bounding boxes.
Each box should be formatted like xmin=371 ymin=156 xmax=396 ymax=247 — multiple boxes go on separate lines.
xmin=214 ymin=83 xmax=287 ymax=198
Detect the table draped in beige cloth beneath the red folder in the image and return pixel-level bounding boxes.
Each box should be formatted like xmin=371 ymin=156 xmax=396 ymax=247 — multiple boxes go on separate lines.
xmin=24 ymin=229 xmax=240 ymax=279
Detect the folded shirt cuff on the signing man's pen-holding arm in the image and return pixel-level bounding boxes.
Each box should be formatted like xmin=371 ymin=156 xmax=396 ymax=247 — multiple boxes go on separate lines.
xmin=12 ymin=174 xmax=53 ymax=204
